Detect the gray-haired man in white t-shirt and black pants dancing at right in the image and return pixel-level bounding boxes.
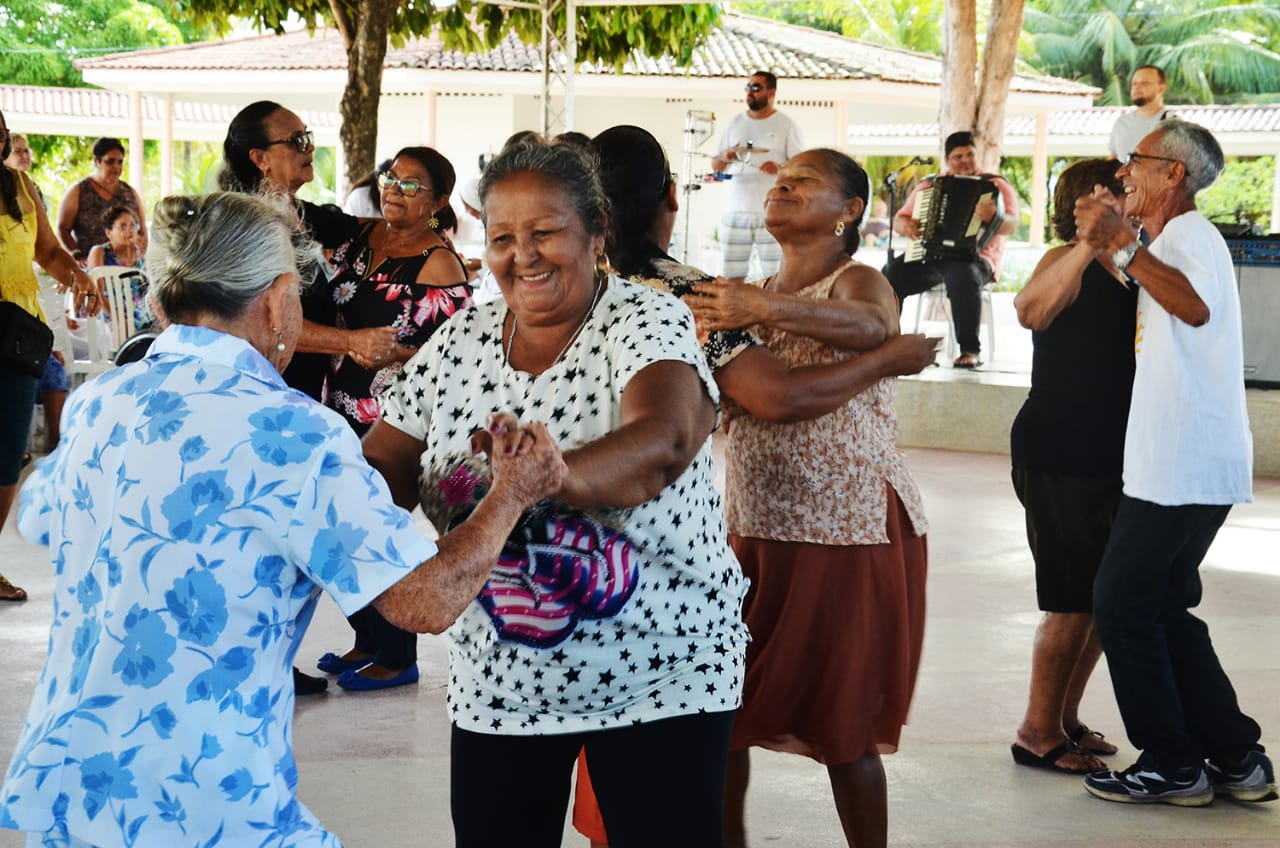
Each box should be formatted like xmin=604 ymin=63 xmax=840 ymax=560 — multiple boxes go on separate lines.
xmin=1075 ymin=120 xmax=1276 ymax=807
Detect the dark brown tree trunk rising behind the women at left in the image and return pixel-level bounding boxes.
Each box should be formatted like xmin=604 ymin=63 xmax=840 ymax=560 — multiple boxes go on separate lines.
xmin=330 ymin=0 xmax=398 ymax=186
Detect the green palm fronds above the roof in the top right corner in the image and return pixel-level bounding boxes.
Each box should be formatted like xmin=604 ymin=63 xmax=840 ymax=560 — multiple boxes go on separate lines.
xmin=1020 ymin=0 xmax=1280 ymax=105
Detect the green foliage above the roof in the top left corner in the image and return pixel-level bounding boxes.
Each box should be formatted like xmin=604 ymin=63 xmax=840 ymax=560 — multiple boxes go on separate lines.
xmin=0 ymin=0 xmax=183 ymax=87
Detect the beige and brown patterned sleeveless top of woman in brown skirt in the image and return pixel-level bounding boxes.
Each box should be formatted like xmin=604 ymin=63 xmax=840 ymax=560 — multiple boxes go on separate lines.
xmin=724 ymin=265 xmax=927 ymax=544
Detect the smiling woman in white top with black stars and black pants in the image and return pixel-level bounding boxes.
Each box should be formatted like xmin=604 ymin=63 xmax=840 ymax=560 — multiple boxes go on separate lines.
xmin=365 ymin=141 xmax=746 ymax=848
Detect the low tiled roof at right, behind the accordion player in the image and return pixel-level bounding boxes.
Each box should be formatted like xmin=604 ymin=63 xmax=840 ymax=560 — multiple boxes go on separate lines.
xmin=849 ymin=104 xmax=1280 ymax=141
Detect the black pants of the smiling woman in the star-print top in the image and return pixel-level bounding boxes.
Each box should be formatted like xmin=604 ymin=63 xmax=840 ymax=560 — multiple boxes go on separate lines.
xmin=449 ymin=711 xmax=736 ymax=848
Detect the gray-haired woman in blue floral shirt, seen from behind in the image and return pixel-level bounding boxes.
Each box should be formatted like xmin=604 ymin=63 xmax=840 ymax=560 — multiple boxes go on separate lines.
xmin=0 ymin=193 xmax=564 ymax=847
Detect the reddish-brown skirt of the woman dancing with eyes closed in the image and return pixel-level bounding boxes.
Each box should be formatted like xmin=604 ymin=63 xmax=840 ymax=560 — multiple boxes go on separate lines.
xmin=730 ymin=488 xmax=928 ymax=765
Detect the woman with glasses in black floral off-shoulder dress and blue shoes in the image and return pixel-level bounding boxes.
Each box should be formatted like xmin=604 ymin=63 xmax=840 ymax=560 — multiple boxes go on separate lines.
xmin=317 ymin=147 xmax=471 ymax=690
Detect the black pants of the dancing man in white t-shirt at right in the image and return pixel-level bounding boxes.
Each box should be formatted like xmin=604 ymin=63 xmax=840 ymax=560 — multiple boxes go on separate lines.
xmin=1093 ymin=496 xmax=1262 ymax=769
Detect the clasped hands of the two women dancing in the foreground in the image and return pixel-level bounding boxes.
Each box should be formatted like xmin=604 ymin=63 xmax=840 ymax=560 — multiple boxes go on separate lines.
xmin=471 ymin=412 xmax=568 ymax=506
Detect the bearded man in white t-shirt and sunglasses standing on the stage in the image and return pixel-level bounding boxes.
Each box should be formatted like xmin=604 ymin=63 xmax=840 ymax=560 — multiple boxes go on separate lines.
xmin=712 ymin=70 xmax=804 ymax=282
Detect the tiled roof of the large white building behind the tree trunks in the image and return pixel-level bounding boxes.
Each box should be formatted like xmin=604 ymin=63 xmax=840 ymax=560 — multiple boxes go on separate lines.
xmin=76 ymin=13 xmax=1093 ymax=94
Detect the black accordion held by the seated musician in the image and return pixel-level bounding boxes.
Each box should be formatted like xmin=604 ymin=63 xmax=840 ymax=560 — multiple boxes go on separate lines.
xmin=902 ymin=175 xmax=1001 ymax=263
